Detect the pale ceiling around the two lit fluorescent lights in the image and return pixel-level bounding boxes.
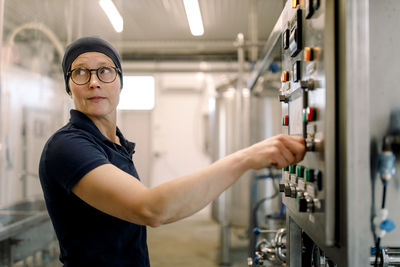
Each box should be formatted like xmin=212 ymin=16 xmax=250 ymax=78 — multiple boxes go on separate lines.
xmin=3 ymin=0 xmax=284 ymax=61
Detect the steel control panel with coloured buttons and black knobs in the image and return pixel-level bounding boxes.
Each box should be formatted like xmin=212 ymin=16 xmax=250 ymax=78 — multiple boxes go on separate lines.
xmin=279 ymin=0 xmax=337 ymax=246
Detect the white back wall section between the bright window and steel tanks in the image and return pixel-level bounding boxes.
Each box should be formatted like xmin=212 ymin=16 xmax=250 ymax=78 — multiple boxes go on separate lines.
xmin=151 ymin=73 xmax=210 ymax=186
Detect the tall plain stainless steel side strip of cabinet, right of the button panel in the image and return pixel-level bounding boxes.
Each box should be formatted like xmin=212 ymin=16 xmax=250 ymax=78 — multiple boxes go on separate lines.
xmin=337 ymin=0 xmax=373 ymax=266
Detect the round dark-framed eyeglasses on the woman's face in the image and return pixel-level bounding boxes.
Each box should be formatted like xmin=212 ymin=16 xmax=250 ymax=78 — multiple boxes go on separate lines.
xmin=68 ymin=67 xmax=121 ymax=85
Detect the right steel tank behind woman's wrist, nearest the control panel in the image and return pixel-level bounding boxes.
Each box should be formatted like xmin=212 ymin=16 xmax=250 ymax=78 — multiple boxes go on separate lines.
xmin=250 ymin=72 xmax=284 ymax=229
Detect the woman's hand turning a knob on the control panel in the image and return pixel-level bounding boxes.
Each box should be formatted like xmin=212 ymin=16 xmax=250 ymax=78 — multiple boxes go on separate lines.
xmin=244 ymin=134 xmax=306 ymax=170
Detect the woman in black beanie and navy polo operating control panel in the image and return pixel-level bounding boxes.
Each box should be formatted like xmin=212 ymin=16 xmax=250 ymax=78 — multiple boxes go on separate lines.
xmin=39 ymin=37 xmax=305 ymax=267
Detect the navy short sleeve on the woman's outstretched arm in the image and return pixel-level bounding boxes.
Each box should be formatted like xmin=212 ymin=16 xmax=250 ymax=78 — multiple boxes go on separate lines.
xmin=42 ymin=132 xmax=110 ymax=193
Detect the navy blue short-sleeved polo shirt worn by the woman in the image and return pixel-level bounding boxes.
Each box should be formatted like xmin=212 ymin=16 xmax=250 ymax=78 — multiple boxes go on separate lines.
xmin=39 ymin=110 xmax=150 ymax=267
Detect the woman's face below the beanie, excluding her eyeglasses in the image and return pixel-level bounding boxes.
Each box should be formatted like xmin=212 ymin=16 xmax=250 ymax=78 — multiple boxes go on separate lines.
xmin=68 ymin=52 xmax=121 ymax=118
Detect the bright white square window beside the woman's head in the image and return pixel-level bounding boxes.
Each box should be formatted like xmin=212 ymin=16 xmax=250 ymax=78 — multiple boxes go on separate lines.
xmin=117 ymin=76 xmax=155 ymax=110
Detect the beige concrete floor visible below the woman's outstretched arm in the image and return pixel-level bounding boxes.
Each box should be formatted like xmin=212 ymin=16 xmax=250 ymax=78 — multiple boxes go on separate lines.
xmin=147 ymin=208 xmax=248 ymax=267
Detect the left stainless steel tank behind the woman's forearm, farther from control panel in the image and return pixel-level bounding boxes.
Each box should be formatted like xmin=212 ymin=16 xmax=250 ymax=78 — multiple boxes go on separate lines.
xmin=210 ymin=79 xmax=250 ymax=227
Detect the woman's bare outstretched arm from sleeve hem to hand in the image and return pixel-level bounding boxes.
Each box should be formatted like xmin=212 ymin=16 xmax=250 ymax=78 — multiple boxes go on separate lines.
xmin=72 ymin=135 xmax=305 ymax=227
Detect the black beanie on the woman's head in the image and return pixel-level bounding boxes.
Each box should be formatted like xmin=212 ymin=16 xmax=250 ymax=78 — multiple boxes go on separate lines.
xmin=62 ymin=37 xmax=122 ymax=93
